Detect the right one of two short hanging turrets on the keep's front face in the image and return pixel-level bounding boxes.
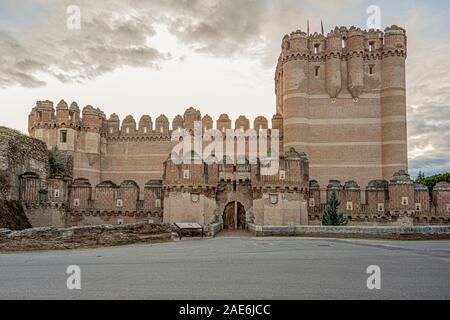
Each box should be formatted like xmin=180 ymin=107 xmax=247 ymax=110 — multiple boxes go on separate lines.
xmin=347 ymin=27 xmax=365 ymax=99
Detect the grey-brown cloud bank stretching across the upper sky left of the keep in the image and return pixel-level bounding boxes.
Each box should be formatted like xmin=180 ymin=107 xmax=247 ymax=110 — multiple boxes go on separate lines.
xmin=0 ymin=0 xmax=355 ymax=88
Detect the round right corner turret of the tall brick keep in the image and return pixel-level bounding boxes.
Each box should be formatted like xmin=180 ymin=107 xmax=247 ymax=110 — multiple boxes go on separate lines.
xmin=381 ymin=25 xmax=408 ymax=180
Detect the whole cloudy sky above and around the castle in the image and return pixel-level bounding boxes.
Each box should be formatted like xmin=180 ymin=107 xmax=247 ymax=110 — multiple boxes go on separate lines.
xmin=0 ymin=0 xmax=450 ymax=177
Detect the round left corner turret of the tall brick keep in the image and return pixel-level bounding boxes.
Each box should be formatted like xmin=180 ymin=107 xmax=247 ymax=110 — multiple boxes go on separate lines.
xmin=282 ymin=31 xmax=310 ymax=153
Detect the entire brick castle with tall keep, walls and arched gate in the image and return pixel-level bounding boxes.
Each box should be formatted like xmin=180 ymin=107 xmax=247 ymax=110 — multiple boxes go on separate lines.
xmin=2 ymin=26 xmax=450 ymax=229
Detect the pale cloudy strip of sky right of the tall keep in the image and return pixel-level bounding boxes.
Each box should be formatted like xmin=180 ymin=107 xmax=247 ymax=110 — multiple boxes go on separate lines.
xmin=405 ymin=8 xmax=450 ymax=176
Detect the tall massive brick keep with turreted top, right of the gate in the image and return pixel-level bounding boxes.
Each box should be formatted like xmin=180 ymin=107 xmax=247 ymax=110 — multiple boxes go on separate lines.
xmin=275 ymin=26 xmax=408 ymax=190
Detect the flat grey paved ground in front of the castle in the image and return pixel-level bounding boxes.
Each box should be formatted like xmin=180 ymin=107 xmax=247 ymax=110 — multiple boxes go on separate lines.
xmin=0 ymin=237 xmax=450 ymax=299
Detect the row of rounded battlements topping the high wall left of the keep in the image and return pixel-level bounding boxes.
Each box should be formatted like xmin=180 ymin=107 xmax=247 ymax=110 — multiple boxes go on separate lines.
xmin=28 ymin=100 xmax=282 ymax=138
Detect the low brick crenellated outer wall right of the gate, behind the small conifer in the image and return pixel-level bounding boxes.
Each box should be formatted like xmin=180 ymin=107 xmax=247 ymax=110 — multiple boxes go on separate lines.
xmin=308 ymin=171 xmax=450 ymax=225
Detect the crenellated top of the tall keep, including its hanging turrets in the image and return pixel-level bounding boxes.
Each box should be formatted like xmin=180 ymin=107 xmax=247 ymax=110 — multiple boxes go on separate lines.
xmin=275 ymin=25 xmax=407 ymax=102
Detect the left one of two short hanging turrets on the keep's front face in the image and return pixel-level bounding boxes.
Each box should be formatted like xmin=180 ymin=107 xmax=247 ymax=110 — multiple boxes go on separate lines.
xmin=325 ymin=27 xmax=342 ymax=99
